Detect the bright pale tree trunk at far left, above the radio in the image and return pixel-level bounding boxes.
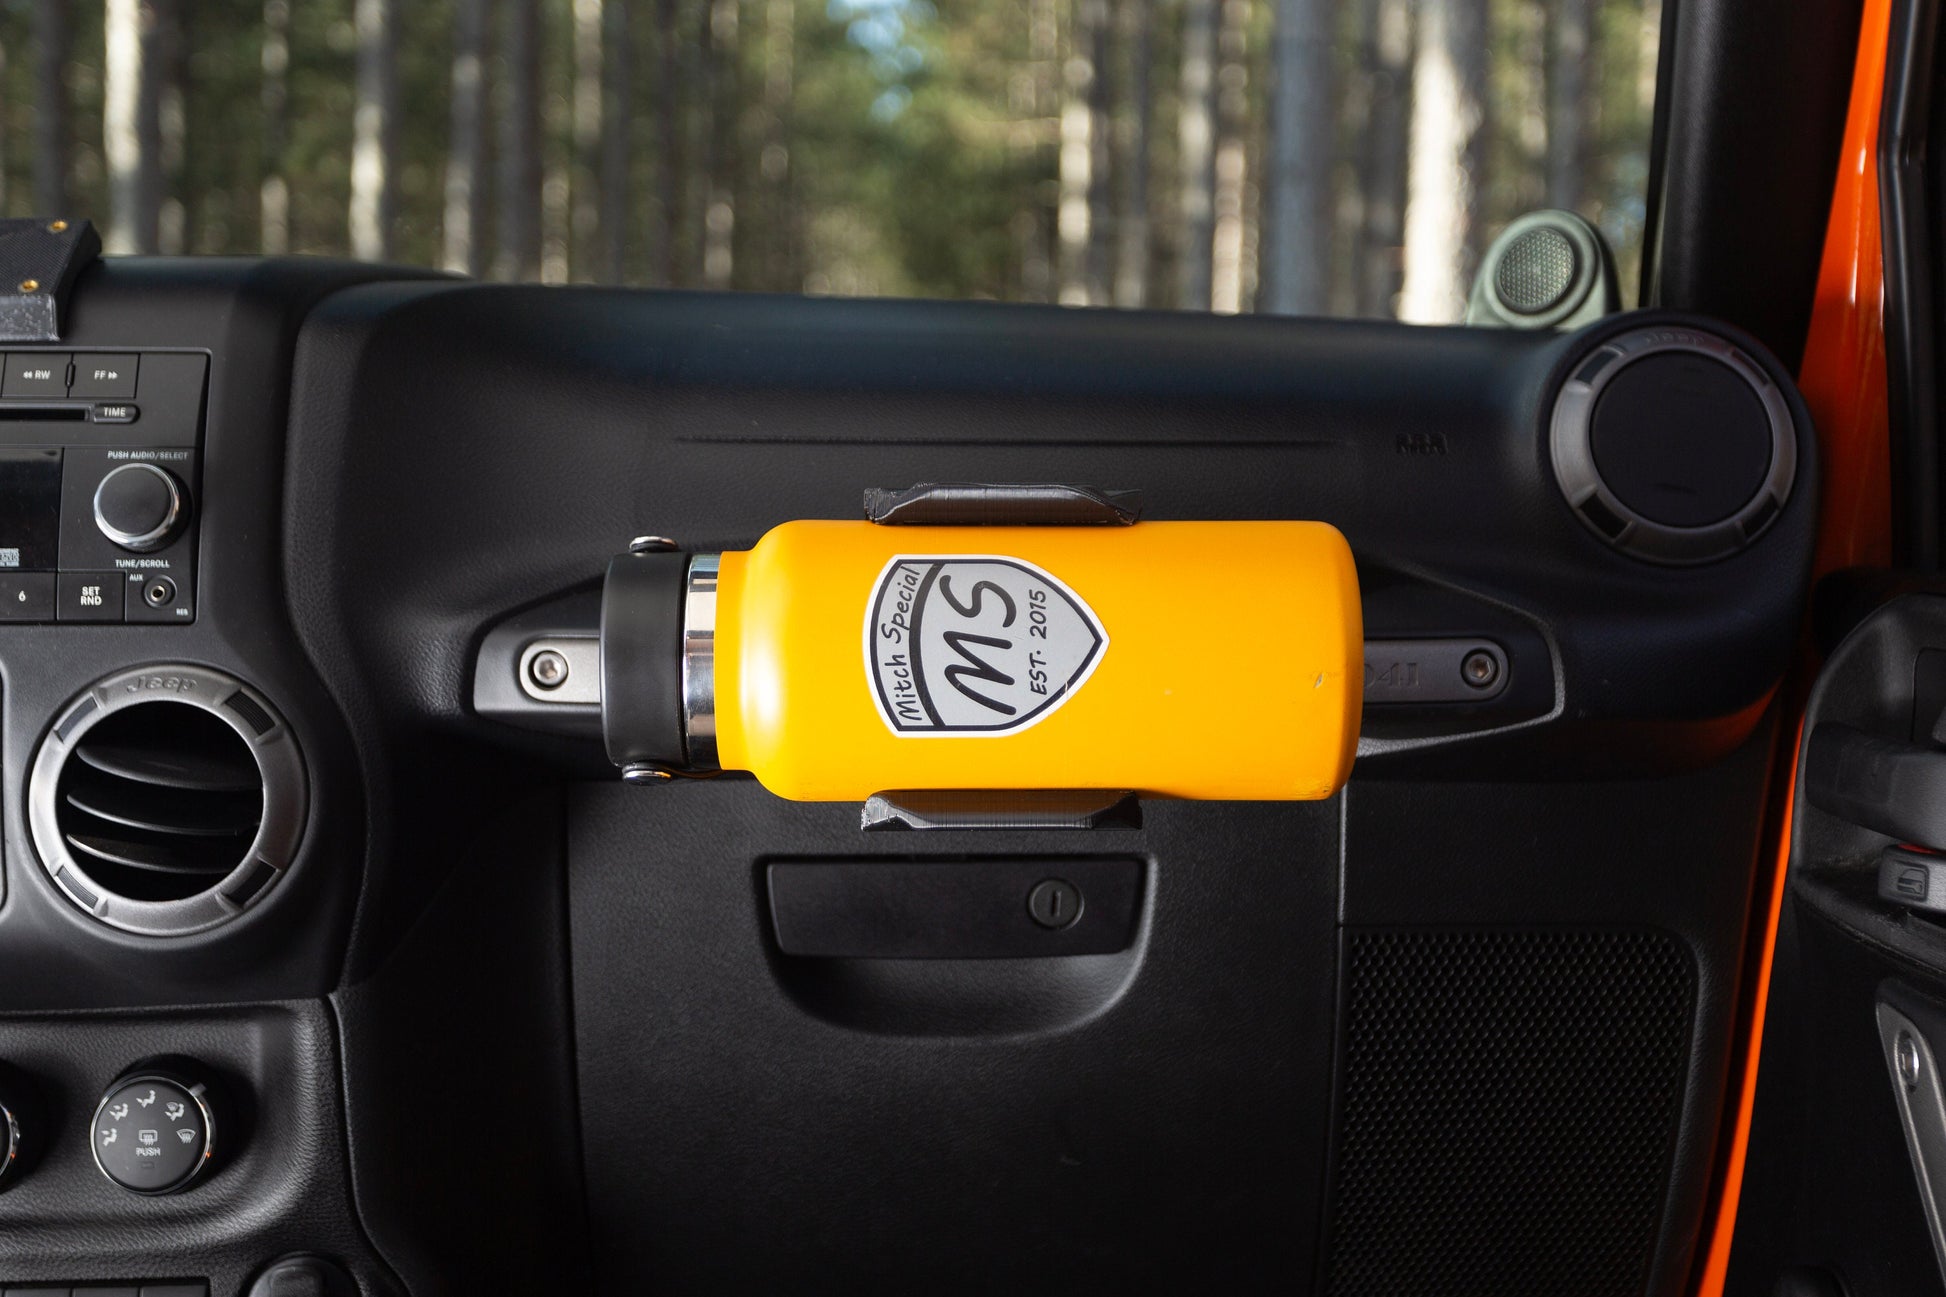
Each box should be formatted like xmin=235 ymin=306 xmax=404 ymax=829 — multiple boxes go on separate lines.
xmin=101 ymin=0 xmax=162 ymax=253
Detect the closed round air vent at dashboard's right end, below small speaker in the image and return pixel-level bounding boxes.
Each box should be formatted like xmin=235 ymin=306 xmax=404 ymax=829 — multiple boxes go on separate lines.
xmin=1549 ymin=325 xmax=1798 ymax=563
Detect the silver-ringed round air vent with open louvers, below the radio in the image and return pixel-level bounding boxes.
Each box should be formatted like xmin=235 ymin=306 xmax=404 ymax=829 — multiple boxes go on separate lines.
xmin=27 ymin=666 xmax=306 ymax=937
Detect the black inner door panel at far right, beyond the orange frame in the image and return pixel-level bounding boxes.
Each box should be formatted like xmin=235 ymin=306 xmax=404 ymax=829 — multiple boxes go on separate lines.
xmin=1728 ymin=594 xmax=1946 ymax=1297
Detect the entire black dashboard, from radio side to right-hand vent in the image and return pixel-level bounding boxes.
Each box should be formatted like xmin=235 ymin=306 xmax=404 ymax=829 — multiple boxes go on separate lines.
xmin=0 ymin=261 xmax=1818 ymax=1293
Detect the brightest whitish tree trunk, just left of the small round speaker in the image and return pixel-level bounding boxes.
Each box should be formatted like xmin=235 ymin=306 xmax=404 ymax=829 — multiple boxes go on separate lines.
xmin=1399 ymin=0 xmax=1487 ymax=323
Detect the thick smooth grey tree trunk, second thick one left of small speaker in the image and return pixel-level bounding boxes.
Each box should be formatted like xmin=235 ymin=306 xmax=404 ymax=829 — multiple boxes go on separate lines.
xmin=1263 ymin=0 xmax=1337 ymax=315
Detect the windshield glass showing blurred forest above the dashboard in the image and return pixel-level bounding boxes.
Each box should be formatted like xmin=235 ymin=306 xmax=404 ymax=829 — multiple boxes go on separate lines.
xmin=0 ymin=0 xmax=1660 ymax=323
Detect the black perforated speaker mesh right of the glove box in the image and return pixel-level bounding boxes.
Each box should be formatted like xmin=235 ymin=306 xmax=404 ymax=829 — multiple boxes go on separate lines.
xmin=1329 ymin=931 xmax=1695 ymax=1297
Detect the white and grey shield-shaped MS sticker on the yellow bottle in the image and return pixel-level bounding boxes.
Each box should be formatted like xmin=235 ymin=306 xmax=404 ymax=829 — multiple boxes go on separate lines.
xmin=864 ymin=555 xmax=1107 ymax=738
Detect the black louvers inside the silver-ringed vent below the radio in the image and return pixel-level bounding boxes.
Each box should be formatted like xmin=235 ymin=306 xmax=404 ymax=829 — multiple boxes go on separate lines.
xmin=54 ymin=703 xmax=263 ymax=902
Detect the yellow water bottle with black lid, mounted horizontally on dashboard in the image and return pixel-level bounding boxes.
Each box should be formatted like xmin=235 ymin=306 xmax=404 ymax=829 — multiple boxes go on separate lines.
xmin=601 ymin=494 xmax=1362 ymax=800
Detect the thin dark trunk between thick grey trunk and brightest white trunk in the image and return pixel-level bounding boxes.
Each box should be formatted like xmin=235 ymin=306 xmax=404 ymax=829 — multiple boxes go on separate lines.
xmin=1356 ymin=0 xmax=1413 ymax=319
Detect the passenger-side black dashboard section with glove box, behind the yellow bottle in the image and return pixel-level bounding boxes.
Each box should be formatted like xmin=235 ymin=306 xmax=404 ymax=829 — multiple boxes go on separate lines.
xmin=286 ymin=284 xmax=1816 ymax=1291
